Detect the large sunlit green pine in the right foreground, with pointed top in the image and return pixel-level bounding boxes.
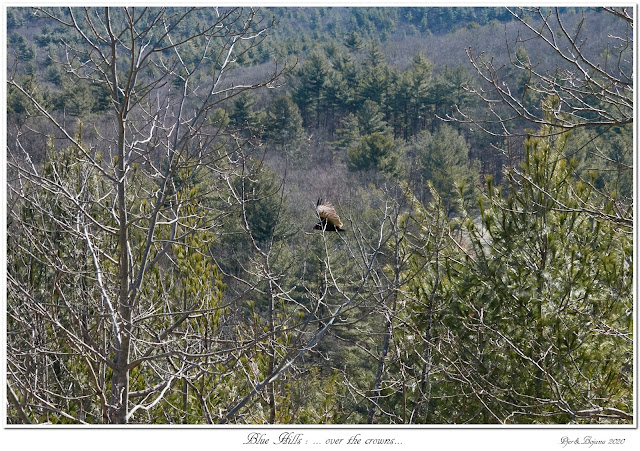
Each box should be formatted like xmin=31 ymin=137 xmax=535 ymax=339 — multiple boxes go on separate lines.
xmin=444 ymin=121 xmax=632 ymax=422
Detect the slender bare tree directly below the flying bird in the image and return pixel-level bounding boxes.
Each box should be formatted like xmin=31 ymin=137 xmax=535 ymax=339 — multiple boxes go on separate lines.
xmin=212 ymin=171 xmax=393 ymax=423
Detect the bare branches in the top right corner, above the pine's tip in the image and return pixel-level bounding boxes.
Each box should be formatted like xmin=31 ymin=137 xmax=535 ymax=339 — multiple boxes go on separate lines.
xmin=448 ymin=8 xmax=634 ymax=137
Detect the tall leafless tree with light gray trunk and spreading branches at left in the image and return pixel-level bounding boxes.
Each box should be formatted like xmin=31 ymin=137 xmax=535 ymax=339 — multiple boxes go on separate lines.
xmin=8 ymin=7 xmax=286 ymax=424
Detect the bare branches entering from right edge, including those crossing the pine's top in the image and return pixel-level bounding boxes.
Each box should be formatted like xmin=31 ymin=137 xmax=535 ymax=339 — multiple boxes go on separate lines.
xmin=445 ymin=8 xmax=635 ymax=232
